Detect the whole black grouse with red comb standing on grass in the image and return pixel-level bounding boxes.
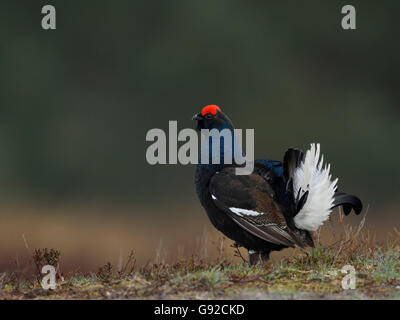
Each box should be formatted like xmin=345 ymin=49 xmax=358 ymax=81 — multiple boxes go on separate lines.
xmin=193 ymin=105 xmax=362 ymax=264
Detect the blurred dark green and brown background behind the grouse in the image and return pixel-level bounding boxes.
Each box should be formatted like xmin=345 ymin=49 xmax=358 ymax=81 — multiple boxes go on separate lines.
xmin=0 ymin=0 xmax=400 ymax=272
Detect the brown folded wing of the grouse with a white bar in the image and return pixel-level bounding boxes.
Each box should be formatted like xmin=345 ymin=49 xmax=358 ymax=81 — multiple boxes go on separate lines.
xmin=210 ymin=168 xmax=304 ymax=247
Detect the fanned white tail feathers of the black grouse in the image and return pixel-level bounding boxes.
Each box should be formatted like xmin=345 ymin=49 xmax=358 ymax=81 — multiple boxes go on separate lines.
xmin=293 ymin=143 xmax=338 ymax=231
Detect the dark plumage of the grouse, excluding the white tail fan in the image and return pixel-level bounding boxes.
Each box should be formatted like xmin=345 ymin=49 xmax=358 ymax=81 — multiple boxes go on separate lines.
xmin=193 ymin=106 xmax=362 ymax=263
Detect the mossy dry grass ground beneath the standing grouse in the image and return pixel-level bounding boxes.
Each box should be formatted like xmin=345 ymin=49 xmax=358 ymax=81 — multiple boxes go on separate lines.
xmin=0 ymin=210 xmax=400 ymax=299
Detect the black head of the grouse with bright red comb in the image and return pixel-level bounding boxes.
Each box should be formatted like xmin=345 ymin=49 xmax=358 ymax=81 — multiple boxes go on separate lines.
xmin=192 ymin=104 xmax=233 ymax=131
